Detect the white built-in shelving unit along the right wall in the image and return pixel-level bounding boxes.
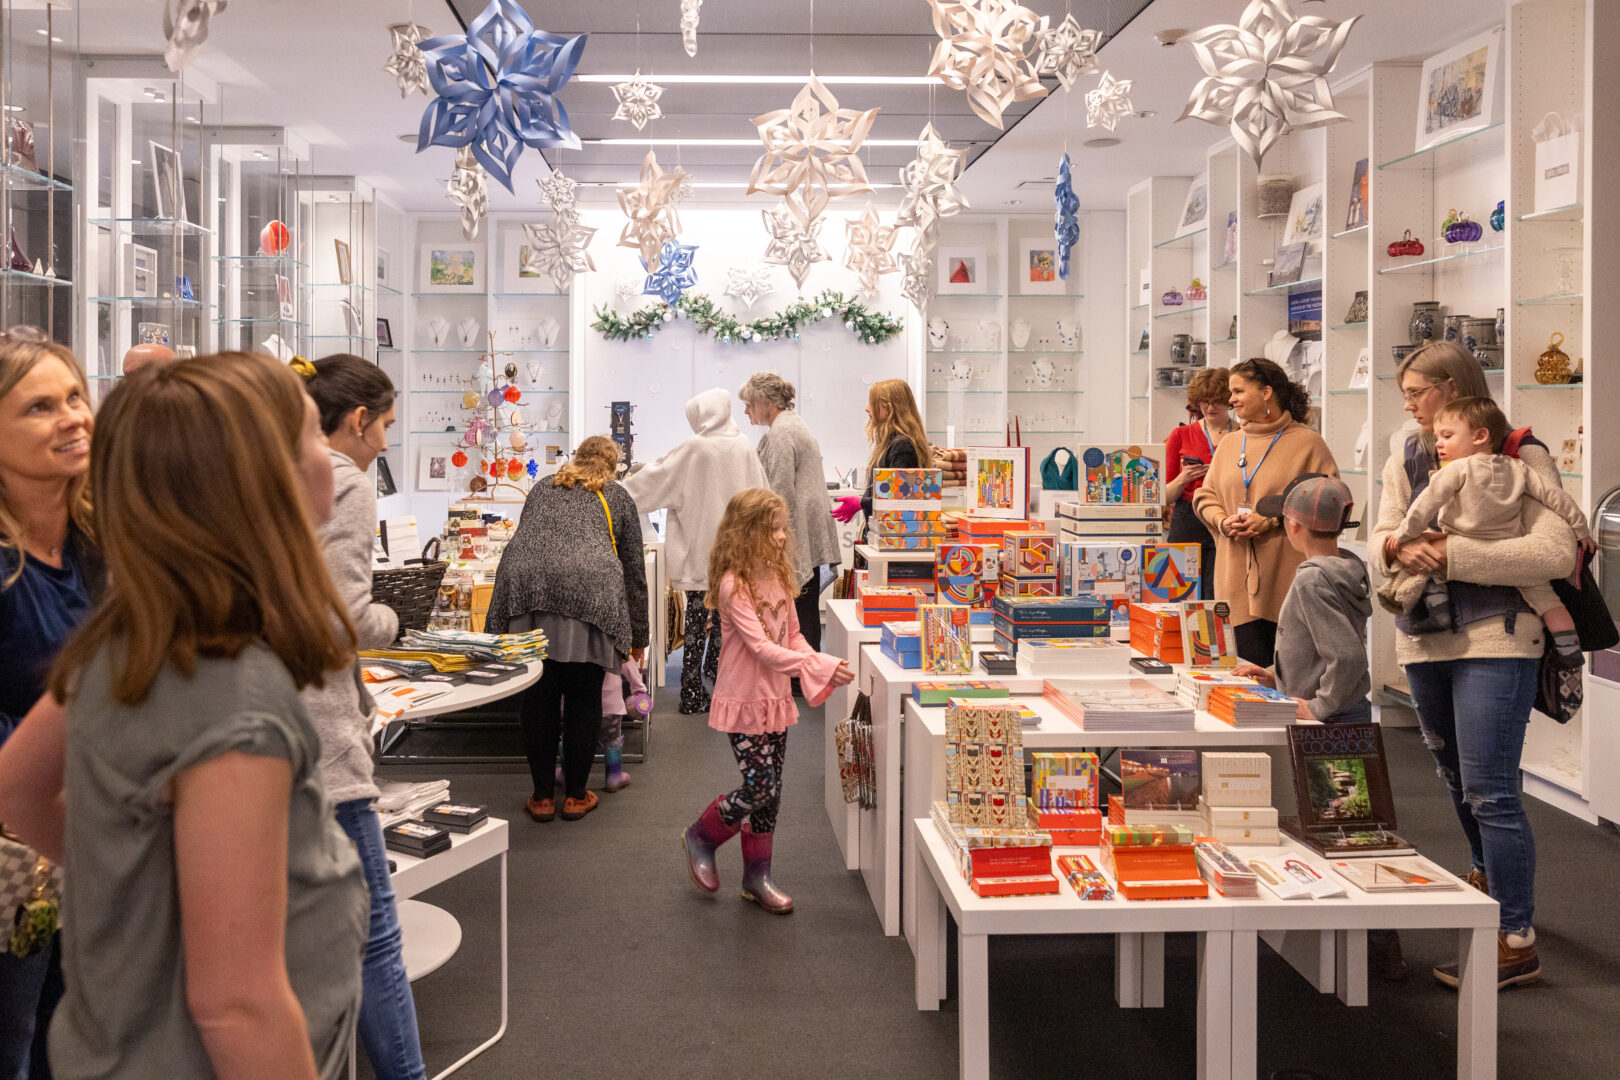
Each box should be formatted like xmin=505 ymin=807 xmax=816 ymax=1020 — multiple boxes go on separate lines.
xmin=1121 ymin=0 xmax=1620 ymax=819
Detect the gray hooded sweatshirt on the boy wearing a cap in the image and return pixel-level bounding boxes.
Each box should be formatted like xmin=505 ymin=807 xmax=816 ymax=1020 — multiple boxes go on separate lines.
xmin=1275 ymin=549 xmax=1372 ymax=721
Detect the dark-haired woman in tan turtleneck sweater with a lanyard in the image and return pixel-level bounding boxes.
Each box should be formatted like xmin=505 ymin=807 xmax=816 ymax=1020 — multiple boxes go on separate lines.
xmin=1192 ymin=359 xmax=1338 ymax=667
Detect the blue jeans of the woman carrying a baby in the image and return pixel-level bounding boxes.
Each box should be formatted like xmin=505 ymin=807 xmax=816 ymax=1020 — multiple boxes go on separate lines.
xmin=1406 ymin=657 xmax=1539 ymax=933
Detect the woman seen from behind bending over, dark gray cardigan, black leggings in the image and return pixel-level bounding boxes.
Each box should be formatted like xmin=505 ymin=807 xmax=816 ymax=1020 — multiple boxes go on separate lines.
xmin=484 ymin=436 xmax=648 ymax=821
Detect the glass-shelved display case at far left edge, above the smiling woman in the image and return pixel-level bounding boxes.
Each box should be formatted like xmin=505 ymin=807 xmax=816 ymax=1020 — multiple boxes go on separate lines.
xmin=0 ymin=3 xmax=81 ymax=343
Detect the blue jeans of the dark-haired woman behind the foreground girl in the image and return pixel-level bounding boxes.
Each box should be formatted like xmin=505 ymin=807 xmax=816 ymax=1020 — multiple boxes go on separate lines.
xmin=337 ymin=798 xmax=428 ymax=1080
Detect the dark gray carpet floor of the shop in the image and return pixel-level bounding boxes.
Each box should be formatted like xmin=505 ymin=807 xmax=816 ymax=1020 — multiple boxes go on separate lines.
xmin=375 ymin=660 xmax=1620 ymax=1080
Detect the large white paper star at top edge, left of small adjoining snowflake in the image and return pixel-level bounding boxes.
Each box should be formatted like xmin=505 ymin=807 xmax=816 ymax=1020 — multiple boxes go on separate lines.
xmin=928 ymin=0 xmax=1047 ymax=128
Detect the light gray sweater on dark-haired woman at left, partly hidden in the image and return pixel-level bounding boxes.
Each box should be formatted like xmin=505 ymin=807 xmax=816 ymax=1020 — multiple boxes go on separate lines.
xmin=300 ymin=450 xmax=400 ymax=803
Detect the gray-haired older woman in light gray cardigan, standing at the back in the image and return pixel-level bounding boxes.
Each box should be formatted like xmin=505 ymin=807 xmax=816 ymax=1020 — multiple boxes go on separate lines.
xmin=737 ymin=372 xmax=842 ymax=649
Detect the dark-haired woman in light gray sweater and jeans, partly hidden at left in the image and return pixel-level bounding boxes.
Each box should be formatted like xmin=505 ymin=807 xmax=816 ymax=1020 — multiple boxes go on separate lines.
xmin=293 ymin=353 xmax=426 ymax=1080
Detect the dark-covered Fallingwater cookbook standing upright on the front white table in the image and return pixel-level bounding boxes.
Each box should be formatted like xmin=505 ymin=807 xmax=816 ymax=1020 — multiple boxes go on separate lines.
xmin=1278 ymin=724 xmax=1411 ymax=855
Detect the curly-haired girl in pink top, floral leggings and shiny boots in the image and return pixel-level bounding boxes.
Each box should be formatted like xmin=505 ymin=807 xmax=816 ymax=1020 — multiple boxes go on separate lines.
xmin=680 ymin=487 xmax=855 ymax=915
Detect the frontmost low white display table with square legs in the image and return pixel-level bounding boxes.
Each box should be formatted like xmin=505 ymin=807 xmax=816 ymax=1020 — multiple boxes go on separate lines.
xmin=910 ymin=818 xmax=1499 ymax=1080
